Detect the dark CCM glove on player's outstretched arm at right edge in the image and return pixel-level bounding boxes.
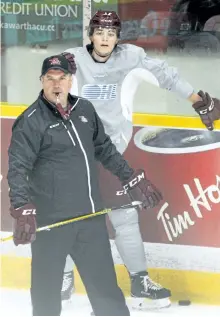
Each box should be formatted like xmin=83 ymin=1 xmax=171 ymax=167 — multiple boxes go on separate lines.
xmin=192 ymin=90 xmax=220 ymax=131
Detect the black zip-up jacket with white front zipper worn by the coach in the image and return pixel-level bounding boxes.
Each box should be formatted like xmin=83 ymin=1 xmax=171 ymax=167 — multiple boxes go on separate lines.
xmin=8 ymin=92 xmax=133 ymax=225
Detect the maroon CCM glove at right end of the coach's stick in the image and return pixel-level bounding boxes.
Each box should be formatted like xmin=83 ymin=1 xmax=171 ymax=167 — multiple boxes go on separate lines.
xmin=122 ymin=170 xmax=163 ymax=209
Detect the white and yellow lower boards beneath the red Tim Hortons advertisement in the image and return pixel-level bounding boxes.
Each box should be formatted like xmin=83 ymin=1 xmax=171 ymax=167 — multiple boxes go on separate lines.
xmin=0 ymin=237 xmax=220 ymax=305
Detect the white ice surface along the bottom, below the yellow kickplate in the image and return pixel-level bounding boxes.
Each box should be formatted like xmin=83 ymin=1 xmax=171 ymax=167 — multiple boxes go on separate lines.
xmin=0 ymin=288 xmax=220 ymax=317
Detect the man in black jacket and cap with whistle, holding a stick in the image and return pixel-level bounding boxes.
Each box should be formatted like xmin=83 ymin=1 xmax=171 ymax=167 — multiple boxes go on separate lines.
xmin=8 ymin=55 xmax=162 ymax=316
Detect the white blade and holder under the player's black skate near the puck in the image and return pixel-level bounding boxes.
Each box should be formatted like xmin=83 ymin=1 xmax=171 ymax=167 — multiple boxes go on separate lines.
xmin=131 ymin=297 xmax=171 ymax=310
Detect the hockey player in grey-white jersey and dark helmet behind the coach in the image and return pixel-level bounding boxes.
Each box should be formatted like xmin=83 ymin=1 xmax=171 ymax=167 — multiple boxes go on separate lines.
xmin=62 ymin=11 xmax=220 ymax=308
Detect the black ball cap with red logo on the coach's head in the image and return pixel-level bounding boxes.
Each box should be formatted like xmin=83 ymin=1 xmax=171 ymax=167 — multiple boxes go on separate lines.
xmin=41 ymin=55 xmax=71 ymax=76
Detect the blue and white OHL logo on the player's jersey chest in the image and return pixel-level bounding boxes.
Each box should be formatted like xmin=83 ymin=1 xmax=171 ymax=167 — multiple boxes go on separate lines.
xmin=82 ymin=84 xmax=117 ymax=100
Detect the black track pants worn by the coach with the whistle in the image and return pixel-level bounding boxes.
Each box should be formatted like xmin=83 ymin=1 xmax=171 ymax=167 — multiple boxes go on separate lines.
xmin=31 ymin=216 xmax=130 ymax=316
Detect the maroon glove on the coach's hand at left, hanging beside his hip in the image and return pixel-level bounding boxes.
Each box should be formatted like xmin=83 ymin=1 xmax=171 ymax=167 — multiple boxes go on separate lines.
xmin=10 ymin=204 xmax=37 ymax=245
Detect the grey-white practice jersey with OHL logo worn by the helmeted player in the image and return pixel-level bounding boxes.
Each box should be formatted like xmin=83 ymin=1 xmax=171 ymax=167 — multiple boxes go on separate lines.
xmin=66 ymin=44 xmax=193 ymax=153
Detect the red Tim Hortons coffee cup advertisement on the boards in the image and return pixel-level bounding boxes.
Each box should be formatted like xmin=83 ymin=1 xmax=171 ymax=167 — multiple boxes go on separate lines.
xmin=1 ymin=119 xmax=220 ymax=248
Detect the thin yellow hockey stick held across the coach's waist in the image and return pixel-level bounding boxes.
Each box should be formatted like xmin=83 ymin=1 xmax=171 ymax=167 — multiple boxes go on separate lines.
xmin=0 ymin=201 xmax=142 ymax=242
